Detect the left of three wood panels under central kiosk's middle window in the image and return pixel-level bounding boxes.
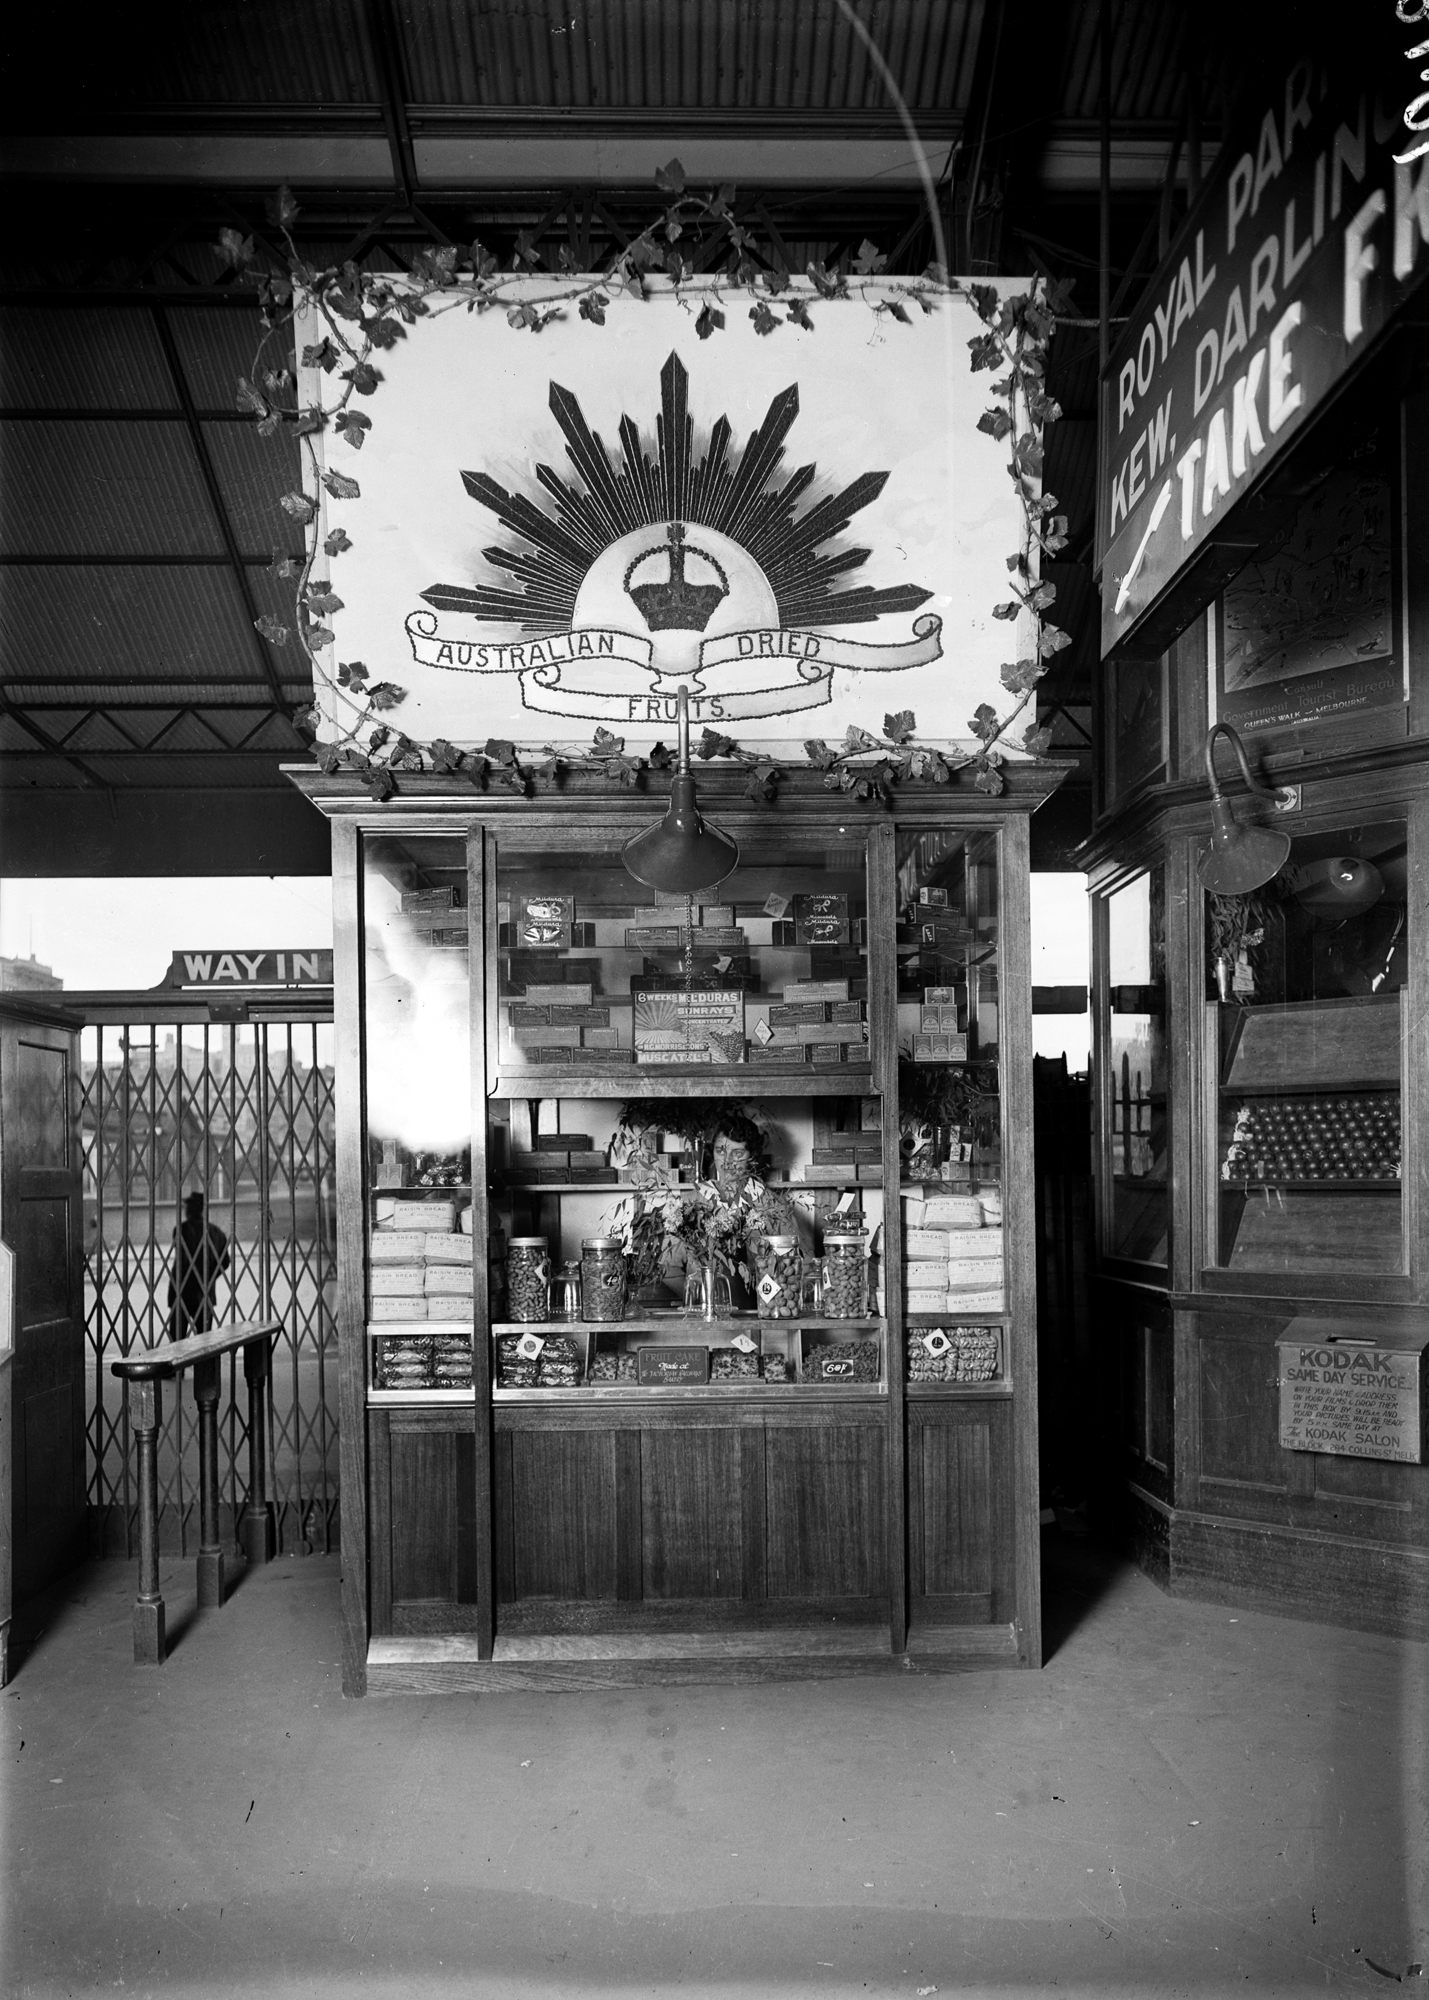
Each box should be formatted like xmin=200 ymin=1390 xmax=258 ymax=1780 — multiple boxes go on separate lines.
xmin=510 ymin=1430 xmax=616 ymax=1598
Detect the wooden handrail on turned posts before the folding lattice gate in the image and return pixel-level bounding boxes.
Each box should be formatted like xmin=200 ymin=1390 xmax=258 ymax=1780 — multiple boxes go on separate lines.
xmin=110 ymin=1320 xmax=282 ymax=1666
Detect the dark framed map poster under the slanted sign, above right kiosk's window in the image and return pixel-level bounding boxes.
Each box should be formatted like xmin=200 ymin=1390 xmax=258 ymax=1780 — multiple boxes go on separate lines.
xmin=1211 ymin=452 xmax=1405 ymax=736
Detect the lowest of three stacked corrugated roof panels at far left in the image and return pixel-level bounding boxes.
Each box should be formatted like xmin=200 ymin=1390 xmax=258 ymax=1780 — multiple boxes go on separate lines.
xmin=0 ymin=566 xmax=280 ymax=690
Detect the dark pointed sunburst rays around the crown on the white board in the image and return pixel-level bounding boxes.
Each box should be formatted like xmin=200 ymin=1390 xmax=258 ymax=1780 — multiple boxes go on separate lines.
xmin=422 ymin=354 xmax=933 ymax=632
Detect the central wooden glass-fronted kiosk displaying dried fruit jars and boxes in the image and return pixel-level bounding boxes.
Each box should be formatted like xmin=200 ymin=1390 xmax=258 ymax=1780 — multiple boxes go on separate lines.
xmin=294 ymin=768 xmax=1059 ymax=1692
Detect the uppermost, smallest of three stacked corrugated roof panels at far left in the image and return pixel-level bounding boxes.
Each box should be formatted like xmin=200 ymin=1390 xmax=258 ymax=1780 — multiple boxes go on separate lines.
xmin=0 ymin=306 xmax=174 ymax=410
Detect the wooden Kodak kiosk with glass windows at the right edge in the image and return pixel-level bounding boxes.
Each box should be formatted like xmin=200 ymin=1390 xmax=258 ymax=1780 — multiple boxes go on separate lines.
xmin=1089 ymin=618 xmax=1429 ymax=1636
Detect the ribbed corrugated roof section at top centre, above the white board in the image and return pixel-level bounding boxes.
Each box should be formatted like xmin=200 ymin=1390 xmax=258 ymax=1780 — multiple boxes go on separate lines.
xmin=398 ymin=0 xmax=985 ymax=110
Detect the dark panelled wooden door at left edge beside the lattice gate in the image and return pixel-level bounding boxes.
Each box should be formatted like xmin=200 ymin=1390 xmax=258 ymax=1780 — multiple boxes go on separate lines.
xmin=0 ymin=1000 xmax=84 ymax=1602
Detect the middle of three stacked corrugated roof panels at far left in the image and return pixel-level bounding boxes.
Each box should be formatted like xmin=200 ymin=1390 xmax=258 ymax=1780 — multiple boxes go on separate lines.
xmin=0 ymin=420 xmax=225 ymax=556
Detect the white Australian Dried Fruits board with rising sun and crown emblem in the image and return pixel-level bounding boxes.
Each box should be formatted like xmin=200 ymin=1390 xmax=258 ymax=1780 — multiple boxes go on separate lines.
xmin=300 ymin=280 xmax=1027 ymax=746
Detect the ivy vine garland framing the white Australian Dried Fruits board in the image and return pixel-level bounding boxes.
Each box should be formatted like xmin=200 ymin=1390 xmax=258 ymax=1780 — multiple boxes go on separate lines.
xmin=218 ymin=160 xmax=1071 ymax=804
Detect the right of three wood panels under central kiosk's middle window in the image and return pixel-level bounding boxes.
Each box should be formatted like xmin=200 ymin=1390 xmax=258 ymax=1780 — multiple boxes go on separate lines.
xmin=765 ymin=1422 xmax=887 ymax=1598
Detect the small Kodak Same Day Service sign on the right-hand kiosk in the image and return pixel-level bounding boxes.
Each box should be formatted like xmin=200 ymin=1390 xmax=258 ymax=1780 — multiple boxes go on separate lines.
xmin=1279 ymin=1322 xmax=1425 ymax=1466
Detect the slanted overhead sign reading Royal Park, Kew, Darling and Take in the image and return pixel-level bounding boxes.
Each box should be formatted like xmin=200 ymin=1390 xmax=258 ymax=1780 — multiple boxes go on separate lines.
xmin=1097 ymin=38 xmax=1429 ymax=652
